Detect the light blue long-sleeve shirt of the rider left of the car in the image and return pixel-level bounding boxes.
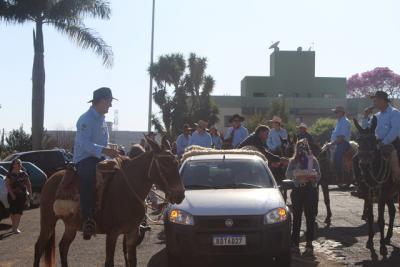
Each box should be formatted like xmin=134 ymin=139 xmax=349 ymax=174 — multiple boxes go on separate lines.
xmin=74 ymin=107 xmax=109 ymax=163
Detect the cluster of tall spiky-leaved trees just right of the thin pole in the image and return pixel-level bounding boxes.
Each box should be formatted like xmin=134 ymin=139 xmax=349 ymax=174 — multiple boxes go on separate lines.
xmin=149 ymin=53 xmax=218 ymax=139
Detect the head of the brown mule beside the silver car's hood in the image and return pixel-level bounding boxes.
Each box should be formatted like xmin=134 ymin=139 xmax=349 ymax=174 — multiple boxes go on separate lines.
xmin=146 ymin=136 xmax=185 ymax=204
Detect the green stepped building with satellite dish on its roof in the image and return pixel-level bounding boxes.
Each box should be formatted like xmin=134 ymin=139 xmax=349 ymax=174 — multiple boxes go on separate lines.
xmin=212 ymin=47 xmax=376 ymax=128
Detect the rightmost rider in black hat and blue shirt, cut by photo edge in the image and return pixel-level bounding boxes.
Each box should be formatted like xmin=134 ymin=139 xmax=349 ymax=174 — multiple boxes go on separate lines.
xmin=362 ymin=91 xmax=400 ymax=185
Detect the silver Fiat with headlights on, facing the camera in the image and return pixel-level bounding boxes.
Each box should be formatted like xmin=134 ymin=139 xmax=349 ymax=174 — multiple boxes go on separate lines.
xmin=164 ymin=152 xmax=291 ymax=266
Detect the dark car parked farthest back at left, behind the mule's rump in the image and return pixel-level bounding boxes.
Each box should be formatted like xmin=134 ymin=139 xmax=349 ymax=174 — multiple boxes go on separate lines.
xmin=4 ymin=149 xmax=71 ymax=177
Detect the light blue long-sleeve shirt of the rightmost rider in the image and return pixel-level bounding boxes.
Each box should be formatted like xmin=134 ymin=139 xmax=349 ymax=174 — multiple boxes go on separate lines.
xmin=362 ymin=105 xmax=400 ymax=145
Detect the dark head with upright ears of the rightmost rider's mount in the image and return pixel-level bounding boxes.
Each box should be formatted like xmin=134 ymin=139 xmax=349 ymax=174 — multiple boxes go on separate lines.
xmin=354 ymin=116 xmax=378 ymax=167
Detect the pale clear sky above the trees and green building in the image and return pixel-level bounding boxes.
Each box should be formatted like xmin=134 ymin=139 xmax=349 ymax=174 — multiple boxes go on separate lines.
xmin=0 ymin=0 xmax=400 ymax=131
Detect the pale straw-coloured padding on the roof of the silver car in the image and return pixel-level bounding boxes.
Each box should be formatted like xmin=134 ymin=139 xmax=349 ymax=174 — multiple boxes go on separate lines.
xmin=182 ymin=146 xmax=267 ymax=162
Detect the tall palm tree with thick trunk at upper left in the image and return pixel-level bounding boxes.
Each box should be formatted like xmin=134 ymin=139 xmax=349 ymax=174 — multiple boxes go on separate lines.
xmin=0 ymin=0 xmax=113 ymax=149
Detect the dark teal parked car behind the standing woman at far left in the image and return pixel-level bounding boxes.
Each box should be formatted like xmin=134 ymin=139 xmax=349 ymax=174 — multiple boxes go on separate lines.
xmin=0 ymin=161 xmax=47 ymax=207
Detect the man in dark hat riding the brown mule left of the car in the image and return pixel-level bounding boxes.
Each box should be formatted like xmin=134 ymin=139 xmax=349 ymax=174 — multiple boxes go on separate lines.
xmin=74 ymin=87 xmax=119 ymax=240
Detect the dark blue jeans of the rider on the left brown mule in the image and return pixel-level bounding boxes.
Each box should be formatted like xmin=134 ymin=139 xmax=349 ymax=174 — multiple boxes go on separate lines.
xmin=76 ymin=157 xmax=103 ymax=221
